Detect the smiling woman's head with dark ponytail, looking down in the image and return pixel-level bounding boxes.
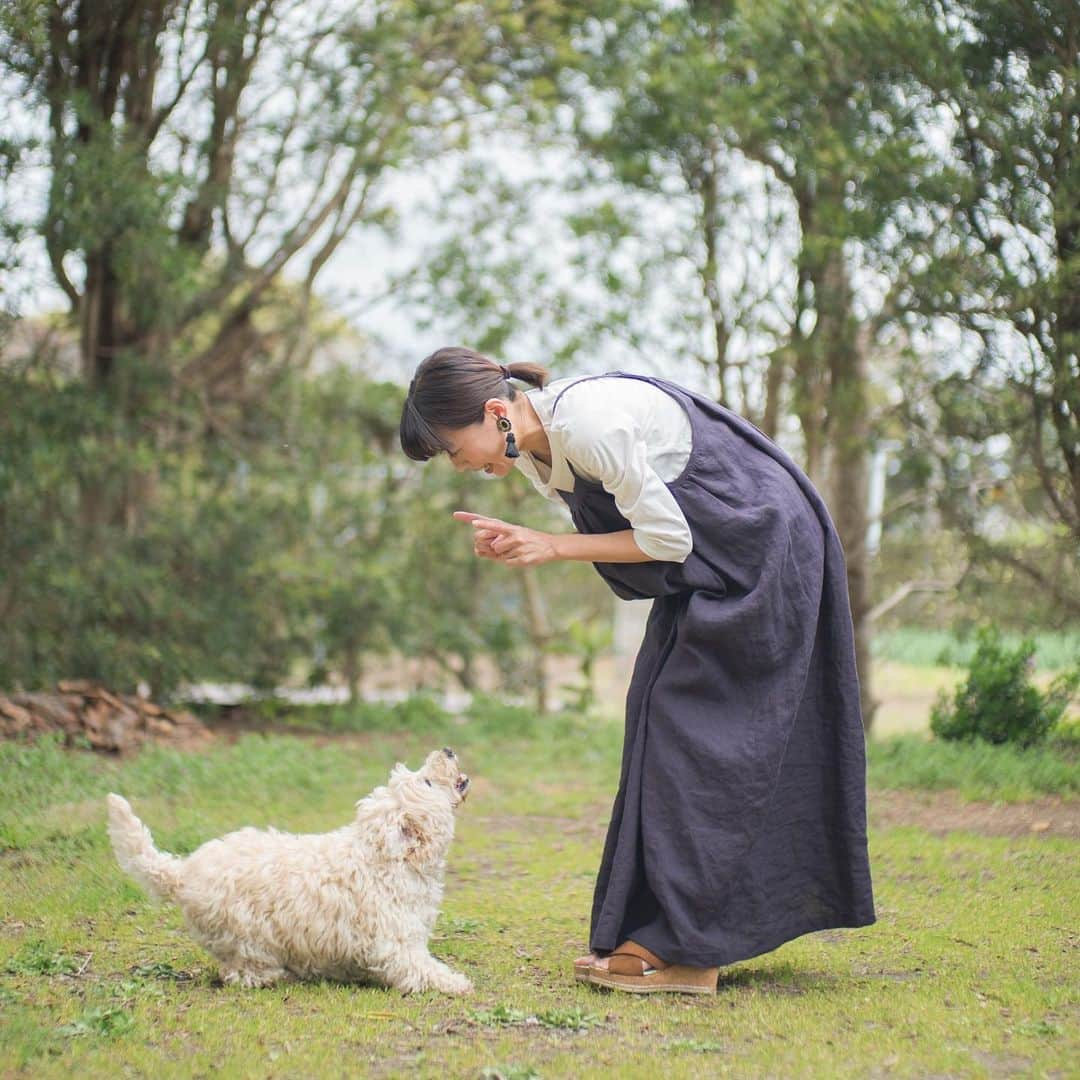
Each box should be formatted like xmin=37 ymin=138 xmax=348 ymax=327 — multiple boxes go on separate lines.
xmin=399 ymin=346 xmax=548 ymax=475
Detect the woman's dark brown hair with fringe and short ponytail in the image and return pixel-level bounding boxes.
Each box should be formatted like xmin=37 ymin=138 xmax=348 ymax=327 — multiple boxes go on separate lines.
xmin=399 ymin=346 xmax=548 ymax=461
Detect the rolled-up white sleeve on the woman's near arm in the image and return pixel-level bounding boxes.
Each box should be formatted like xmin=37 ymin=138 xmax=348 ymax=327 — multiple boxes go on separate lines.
xmin=559 ymin=412 xmax=693 ymax=563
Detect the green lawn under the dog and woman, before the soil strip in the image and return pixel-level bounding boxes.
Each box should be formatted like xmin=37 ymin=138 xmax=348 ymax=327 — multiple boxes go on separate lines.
xmin=0 ymin=714 xmax=1080 ymax=1078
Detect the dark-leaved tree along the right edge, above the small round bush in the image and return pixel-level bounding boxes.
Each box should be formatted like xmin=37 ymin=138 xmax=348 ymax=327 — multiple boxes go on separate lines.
xmin=892 ymin=0 xmax=1080 ymax=620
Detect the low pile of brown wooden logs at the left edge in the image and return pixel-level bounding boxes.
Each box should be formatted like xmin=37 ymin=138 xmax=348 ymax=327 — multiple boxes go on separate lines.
xmin=0 ymin=679 xmax=213 ymax=754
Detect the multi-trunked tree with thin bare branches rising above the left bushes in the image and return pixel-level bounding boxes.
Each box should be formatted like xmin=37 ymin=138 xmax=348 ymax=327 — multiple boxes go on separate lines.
xmin=0 ymin=0 xmax=548 ymax=535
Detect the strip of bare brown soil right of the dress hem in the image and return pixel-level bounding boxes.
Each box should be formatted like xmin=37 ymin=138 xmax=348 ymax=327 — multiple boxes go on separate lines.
xmin=868 ymin=788 xmax=1080 ymax=840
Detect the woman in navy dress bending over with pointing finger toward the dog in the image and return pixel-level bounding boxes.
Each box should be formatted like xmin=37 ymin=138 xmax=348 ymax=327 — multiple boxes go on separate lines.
xmin=401 ymin=348 xmax=875 ymax=993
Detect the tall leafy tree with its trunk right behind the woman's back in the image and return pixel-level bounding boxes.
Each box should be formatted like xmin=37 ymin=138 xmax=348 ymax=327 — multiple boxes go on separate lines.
xmin=533 ymin=0 xmax=954 ymax=725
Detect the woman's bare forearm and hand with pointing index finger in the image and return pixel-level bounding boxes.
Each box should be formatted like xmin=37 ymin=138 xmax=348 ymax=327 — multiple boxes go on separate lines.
xmin=454 ymin=510 xmax=654 ymax=566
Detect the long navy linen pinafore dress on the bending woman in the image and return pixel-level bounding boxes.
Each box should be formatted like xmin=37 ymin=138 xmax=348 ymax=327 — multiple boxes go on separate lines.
xmin=552 ymin=372 xmax=875 ymax=967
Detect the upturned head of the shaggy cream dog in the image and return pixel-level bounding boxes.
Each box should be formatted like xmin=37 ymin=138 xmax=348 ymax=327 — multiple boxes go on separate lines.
xmin=356 ymin=746 xmax=470 ymax=867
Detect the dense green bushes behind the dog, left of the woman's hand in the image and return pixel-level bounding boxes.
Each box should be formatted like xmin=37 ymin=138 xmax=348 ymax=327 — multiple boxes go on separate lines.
xmin=0 ymin=349 xmax=603 ymax=695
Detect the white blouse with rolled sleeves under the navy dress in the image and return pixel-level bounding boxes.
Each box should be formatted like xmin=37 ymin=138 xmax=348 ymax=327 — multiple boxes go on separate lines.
xmin=515 ymin=378 xmax=693 ymax=563
